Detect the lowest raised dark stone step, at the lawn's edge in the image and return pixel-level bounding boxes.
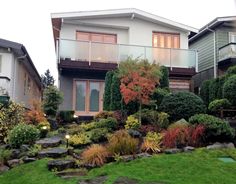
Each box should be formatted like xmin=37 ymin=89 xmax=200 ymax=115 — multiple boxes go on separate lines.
xmin=48 ymin=160 xmax=75 ymax=171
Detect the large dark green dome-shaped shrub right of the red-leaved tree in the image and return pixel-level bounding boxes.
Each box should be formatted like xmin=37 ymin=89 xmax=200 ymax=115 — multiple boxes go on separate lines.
xmin=160 ymin=92 xmax=206 ymax=121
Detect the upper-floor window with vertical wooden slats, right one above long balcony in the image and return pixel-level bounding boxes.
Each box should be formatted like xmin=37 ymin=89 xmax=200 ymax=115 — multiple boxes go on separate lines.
xmin=152 ymin=32 xmax=180 ymax=48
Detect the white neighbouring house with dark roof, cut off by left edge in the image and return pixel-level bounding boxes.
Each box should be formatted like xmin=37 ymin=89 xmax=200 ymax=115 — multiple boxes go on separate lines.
xmin=0 ymin=39 xmax=42 ymax=108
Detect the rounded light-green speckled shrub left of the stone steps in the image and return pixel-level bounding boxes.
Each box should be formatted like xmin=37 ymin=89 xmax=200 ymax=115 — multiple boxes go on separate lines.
xmin=9 ymin=124 xmax=40 ymax=148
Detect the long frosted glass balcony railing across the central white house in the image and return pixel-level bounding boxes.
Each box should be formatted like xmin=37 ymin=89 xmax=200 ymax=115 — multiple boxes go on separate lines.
xmin=57 ymin=39 xmax=197 ymax=71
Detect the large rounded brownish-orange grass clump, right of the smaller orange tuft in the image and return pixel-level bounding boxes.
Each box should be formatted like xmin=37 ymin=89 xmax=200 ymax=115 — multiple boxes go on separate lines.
xmin=108 ymin=130 xmax=138 ymax=155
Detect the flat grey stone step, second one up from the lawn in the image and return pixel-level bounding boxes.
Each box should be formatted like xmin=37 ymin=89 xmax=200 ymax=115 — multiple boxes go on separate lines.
xmin=38 ymin=148 xmax=67 ymax=158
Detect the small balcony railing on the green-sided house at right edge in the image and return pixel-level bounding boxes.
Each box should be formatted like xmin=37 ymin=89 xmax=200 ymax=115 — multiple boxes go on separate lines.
xmin=219 ymin=43 xmax=236 ymax=62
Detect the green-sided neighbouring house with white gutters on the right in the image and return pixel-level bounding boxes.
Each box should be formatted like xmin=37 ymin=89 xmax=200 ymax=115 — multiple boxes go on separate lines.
xmin=189 ymin=16 xmax=236 ymax=92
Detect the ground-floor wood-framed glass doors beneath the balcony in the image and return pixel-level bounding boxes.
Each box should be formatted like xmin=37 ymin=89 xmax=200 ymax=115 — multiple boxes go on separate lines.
xmin=74 ymin=80 xmax=104 ymax=114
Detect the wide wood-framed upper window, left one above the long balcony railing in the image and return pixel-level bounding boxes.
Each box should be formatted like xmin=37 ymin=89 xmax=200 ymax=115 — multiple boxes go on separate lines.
xmin=76 ymin=31 xmax=117 ymax=44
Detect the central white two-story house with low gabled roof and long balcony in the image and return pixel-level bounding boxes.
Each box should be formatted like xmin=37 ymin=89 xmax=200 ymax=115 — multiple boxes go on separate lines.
xmin=51 ymin=9 xmax=197 ymax=116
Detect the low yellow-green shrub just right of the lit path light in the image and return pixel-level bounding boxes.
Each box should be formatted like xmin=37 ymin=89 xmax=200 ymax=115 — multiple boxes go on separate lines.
xmin=69 ymin=133 xmax=91 ymax=147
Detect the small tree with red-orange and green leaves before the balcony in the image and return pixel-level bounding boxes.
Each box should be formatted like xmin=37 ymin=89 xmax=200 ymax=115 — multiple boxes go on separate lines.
xmin=119 ymin=58 xmax=161 ymax=122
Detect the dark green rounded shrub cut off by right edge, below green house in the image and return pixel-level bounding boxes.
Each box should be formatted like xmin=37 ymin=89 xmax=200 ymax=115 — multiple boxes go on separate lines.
xmin=223 ymin=75 xmax=236 ymax=106
